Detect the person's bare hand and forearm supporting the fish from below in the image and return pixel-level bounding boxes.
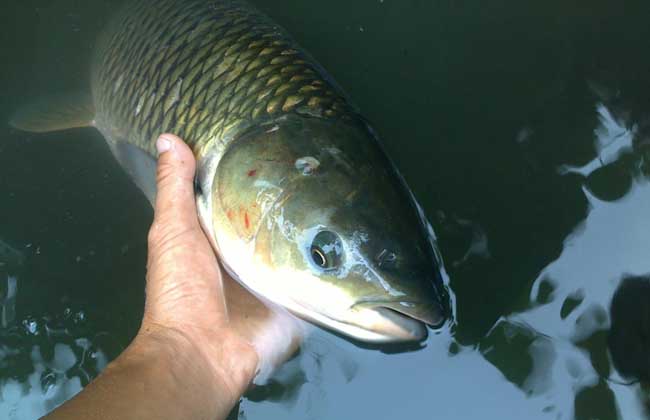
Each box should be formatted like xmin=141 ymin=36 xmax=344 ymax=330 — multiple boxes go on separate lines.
xmin=47 ymin=135 xmax=302 ymax=420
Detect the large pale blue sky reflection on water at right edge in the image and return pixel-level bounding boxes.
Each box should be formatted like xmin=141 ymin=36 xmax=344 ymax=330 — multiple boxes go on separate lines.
xmin=507 ymin=180 xmax=650 ymax=418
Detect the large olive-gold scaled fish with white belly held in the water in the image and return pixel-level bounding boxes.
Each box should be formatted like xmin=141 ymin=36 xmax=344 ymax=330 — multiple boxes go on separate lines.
xmin=10 ymin=0 xmax=449 ymax=352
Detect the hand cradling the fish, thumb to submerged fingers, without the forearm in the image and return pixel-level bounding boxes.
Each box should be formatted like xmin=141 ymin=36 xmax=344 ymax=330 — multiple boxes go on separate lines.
xmin=142 ymin=135 xmax=303 ymax=392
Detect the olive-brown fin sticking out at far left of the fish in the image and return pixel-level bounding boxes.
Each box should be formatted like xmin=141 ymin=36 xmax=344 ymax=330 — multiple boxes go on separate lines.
xmin=9 ymin=93 xmax=95 ymax=133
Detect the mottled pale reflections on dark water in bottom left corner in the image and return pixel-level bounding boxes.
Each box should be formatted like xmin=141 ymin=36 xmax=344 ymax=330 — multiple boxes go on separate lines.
xmin=0 ymin=277 xmax=108 ymax=420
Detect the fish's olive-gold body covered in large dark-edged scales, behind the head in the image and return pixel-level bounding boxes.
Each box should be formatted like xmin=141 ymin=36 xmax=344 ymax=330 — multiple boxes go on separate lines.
xmin=93 ymin=0 xmax=355 ymax=154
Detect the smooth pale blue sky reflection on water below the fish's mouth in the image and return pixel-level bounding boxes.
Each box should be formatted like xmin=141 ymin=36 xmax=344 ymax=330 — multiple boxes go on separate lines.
xmin=241 ymin=331 xmax=568 ymax=419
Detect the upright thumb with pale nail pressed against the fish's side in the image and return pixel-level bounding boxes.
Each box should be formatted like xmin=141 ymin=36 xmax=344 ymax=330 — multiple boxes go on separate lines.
xmin=154 ymin=134 xmax=199 ymax=231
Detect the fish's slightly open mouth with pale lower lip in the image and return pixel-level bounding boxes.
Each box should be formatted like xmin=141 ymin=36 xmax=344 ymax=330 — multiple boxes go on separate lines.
xmin=346 ymin=301 xmax=445 ymax=343
